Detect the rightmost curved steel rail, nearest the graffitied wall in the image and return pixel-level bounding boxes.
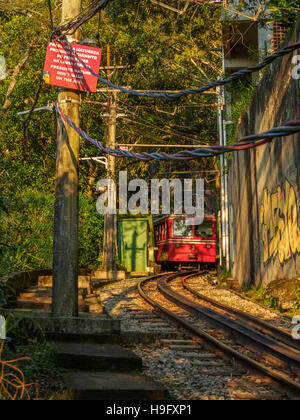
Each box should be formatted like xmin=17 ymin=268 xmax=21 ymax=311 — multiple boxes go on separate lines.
xmin=182 ymin=276 xmax=300 ymax=351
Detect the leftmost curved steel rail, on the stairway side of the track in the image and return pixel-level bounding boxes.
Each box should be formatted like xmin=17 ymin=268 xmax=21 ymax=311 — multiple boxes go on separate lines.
xmin=138 ymin=273 xmax=300 ymax=400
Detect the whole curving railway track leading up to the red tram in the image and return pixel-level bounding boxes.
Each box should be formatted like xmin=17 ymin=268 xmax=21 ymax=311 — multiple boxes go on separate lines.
xmin=138 ymin=271 xmax=300 ymax=399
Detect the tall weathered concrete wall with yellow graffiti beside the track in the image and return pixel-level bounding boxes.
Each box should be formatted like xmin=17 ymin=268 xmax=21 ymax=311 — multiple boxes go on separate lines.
xmin=229 ymin=21 xmax=300 ymax=286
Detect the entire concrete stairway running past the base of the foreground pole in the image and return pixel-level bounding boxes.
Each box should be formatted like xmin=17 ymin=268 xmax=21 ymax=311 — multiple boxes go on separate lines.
xmin=7 ymin=277 xmax=168 ymax=400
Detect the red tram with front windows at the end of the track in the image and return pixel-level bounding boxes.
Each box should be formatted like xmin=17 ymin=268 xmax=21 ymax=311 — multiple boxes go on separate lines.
xmin=154 ymin=215 xmax=217 ymax=269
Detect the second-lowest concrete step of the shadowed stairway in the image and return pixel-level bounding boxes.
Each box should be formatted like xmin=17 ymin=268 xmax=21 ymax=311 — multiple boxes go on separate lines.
xmin=53 ymin=342 xmax=142 ymax=372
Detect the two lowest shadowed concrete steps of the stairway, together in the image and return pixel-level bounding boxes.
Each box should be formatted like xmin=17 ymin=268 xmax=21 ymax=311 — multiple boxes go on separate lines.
xmin=48 ymin=334 xmax=169 ymax=400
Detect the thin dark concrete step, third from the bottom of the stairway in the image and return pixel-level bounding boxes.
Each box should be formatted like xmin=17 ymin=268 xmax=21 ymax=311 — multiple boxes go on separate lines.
xmin=46 ymin=332 xmax=120 ymax=344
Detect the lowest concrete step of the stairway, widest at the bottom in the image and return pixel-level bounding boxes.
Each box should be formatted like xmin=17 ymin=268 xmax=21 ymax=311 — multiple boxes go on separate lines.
xmin=65 ymin=372 xmax=169 ymax=400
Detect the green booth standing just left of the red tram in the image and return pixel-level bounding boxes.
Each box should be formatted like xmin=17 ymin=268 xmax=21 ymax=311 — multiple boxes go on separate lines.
xmin=118 ymin=215 xmax=160 ymax=274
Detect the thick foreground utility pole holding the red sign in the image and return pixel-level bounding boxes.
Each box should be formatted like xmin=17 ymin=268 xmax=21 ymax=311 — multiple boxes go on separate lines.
xmin=52 ymin=0 xmax=81 ymax=317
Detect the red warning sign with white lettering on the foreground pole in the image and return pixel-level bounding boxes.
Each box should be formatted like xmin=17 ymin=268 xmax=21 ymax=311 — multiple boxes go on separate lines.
xmin=44 ymin=42 xmax=102 ymax=92
